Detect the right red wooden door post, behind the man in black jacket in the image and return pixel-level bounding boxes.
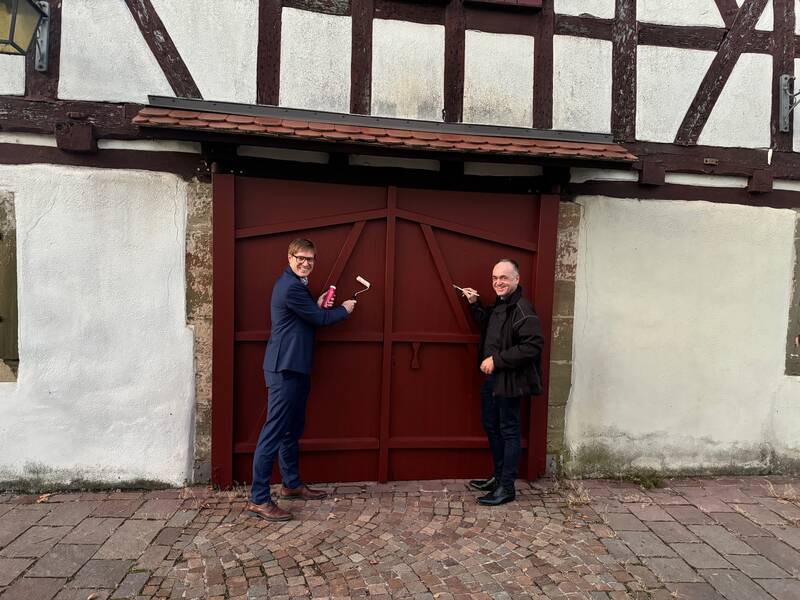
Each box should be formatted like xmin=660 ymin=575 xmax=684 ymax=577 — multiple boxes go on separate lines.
xmin=528 ymin=194 xmax=559 ymax=479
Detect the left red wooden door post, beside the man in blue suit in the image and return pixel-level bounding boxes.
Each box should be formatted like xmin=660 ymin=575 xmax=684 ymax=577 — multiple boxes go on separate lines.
xmin=211 ymin=175 xmax=235 ymax=487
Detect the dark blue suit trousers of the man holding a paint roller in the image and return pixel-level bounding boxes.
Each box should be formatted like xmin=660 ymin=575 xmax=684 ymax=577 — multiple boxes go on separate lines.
xmin=250 ymin=371 xmax=311 ymax=504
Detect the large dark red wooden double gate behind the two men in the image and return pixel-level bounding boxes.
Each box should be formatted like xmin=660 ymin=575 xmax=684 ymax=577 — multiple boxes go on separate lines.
xmin=212 ymin=176 xmax=557 ymax=485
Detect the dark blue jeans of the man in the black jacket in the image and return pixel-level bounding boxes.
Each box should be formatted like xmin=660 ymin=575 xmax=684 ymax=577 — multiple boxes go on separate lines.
xmin=481 ymin=375 xmax=522 ymax=490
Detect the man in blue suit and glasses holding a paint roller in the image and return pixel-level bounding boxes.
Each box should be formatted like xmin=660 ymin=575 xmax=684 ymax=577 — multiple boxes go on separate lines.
xmin=247 ymin=239 xmax=356 ymax=521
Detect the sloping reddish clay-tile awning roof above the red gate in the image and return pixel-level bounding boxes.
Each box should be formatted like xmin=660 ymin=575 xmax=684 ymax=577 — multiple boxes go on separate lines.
xmin=133 ymin=107 xmax=636 ymax=163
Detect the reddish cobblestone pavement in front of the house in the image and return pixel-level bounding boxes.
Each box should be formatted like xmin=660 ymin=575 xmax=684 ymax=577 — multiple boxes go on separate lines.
xmin=0 ymin=477 xmax=800 ymax=600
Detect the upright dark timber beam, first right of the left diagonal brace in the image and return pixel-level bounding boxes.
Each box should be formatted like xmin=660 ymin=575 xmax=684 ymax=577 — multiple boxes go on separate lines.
xmin=256 ymin=0 xmax=281 ymax=106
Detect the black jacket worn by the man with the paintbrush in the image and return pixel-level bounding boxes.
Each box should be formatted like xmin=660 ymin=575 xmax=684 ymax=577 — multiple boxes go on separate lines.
xmin=470 ymin=287 xmax=544 ymax=398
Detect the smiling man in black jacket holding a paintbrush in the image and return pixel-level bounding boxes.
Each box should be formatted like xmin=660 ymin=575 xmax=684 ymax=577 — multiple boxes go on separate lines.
xmin=463 ymin=258 xmax=544 ymax=506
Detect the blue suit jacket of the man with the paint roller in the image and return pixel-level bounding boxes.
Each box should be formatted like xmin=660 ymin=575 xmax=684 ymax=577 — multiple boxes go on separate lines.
xmin=264 ymin=267 xmax=348 ymax=373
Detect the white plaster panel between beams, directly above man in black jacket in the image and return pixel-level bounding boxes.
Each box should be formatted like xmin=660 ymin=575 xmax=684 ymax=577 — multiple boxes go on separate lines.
xmin=464 ymin=30 xmax=534 ymax=127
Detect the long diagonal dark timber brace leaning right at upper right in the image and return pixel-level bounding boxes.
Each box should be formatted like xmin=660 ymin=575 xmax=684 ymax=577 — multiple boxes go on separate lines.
xmin=675 ymin=0 xmax=767 ymax=145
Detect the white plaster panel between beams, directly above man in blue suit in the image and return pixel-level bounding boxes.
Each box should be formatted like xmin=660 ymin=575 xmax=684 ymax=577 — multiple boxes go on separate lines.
xmin=280 ymin=8 xmax=352 ymax=113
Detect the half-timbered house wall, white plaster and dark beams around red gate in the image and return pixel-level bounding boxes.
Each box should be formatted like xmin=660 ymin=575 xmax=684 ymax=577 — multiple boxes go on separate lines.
xmin=0 ymin=0 xmax=800 ymax=482
